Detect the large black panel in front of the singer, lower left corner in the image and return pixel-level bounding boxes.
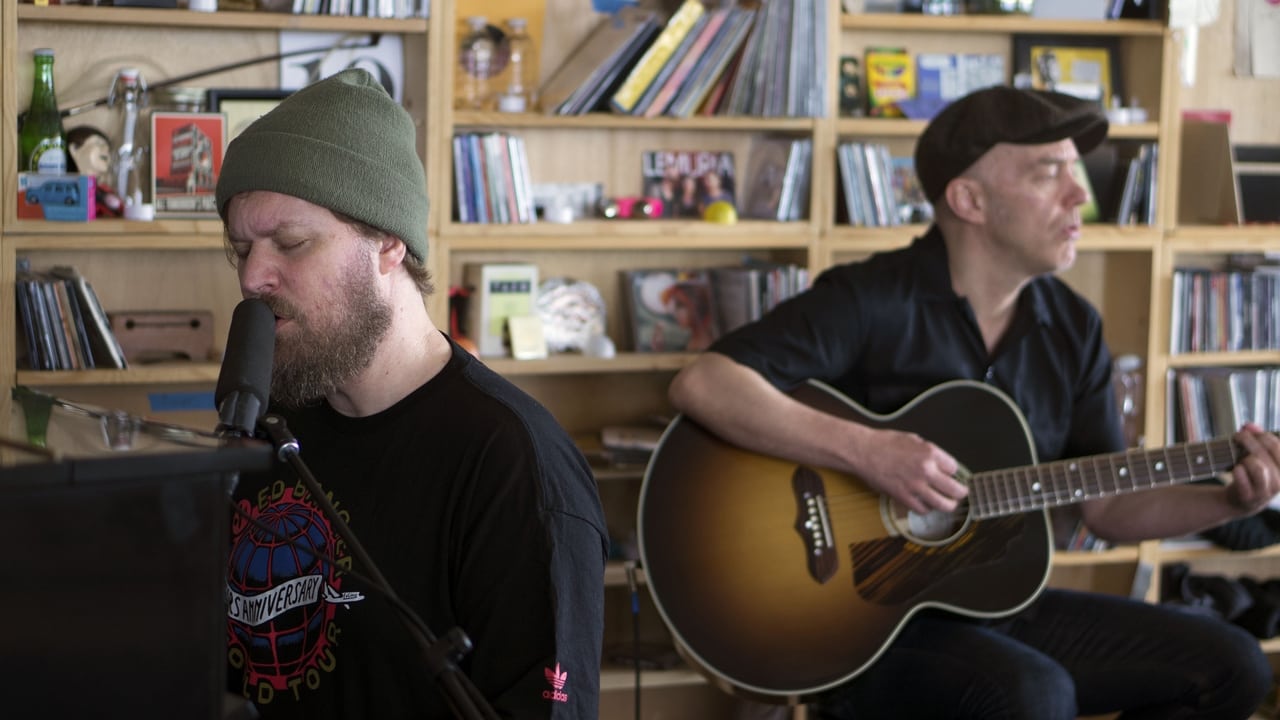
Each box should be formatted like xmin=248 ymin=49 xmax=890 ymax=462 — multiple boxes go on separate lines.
xmin=0 ymin=441 xmax=273 ymax=720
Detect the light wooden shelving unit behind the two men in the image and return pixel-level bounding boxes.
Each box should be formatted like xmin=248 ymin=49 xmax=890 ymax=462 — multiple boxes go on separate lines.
xmin=10 ymin=0 xmax=1280 ymax=717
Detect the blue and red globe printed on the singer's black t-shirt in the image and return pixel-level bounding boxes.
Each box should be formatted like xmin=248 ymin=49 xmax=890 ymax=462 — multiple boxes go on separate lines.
xmin=228 ymin=488 xmax=338 ymax=689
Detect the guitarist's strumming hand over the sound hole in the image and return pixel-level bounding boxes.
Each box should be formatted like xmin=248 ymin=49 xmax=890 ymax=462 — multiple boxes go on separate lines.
xmin=858 ymin=429 xmax=969 ymax=514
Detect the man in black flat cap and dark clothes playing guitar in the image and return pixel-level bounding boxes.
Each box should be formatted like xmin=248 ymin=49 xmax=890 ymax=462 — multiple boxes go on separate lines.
xmin=669 ymin=87 xmax=1280 ymax=720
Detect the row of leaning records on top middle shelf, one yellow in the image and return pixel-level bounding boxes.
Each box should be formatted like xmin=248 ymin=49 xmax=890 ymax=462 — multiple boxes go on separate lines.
xmin=540 ymin=0 xmax=827 ymax=118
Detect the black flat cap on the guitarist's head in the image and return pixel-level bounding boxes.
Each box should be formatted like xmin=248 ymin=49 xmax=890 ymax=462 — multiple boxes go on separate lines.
xmin=915 ymin=86 xmax=1107 ymax=202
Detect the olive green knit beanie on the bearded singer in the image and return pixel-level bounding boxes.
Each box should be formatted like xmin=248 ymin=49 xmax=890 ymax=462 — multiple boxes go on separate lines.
xmin=216 ymin=69 xmax=428 ymax=263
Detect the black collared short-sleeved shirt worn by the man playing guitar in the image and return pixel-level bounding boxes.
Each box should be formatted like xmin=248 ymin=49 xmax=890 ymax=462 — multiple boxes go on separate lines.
xmin=710 ymin=225 xmax=1124 ymax=461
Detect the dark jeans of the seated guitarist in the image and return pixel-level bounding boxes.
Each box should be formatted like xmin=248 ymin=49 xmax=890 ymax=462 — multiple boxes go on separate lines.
xmin=810 ymin=589 xmax=1271 ymax=720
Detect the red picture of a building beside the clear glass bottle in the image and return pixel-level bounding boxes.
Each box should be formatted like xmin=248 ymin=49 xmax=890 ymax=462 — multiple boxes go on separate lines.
xmin=151 ymin=113 xmax=227 ymax=218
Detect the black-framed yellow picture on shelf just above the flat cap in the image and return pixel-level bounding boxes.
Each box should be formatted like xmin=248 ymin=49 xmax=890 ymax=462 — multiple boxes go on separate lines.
xmin=1014 ymin=35 xmax=1124 ymax=108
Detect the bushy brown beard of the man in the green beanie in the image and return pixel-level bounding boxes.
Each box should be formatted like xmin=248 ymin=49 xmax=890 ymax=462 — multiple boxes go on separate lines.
xmin=262 ymin=263 xmax=392 ymax=407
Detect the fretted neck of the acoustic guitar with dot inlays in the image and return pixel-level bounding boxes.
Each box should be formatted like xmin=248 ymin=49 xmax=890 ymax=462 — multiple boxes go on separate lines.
xmin=969 ymin=430 xmax=1244 ymax=519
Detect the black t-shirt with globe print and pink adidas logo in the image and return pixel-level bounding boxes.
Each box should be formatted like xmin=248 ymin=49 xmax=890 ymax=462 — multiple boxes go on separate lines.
xmin=228 ymin=333 xmax=608 ymax=720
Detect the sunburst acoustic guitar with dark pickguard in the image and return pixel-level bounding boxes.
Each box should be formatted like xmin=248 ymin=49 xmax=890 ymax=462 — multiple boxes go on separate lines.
xmin=637 ymin=380 xmax=1243 ymax=703
